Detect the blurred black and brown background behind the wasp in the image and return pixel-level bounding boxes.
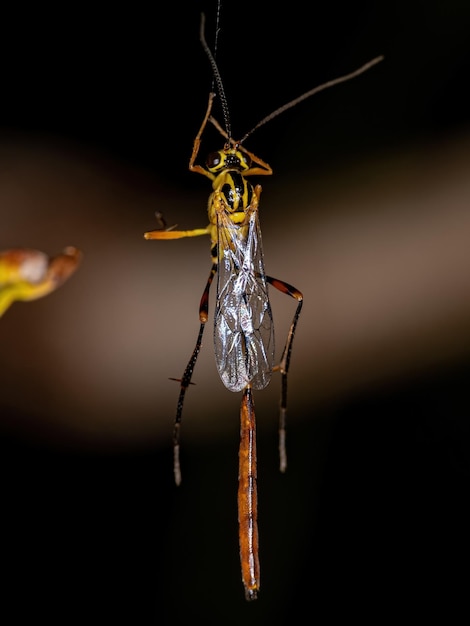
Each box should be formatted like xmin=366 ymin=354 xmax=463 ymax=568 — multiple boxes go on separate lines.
xmin=0 ymin=0 xmax=470 ymax=625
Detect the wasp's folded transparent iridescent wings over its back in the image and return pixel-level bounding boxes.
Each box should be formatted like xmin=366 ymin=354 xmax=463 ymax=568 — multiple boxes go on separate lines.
xmin=214 ymin=205 xmax=274 ymax=391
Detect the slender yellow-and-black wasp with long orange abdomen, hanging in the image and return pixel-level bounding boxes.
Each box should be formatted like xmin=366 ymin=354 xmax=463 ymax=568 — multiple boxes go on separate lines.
xmin=144 ymin=8 xmax=383 ymax=600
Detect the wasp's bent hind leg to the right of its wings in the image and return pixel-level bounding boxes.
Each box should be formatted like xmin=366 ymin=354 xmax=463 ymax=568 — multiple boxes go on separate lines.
xmin=266 ymin=276 xmax=304 ymax=472
